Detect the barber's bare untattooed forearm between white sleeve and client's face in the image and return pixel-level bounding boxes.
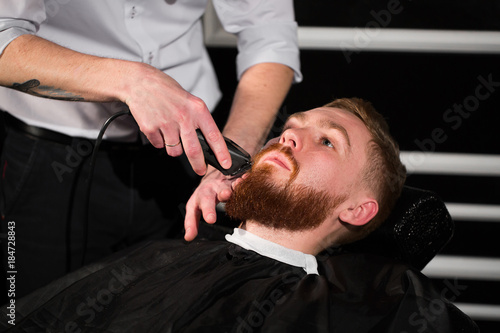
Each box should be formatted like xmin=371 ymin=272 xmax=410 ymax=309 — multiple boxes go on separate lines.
xmin=223 ymin=63 xmax=294 ymax=155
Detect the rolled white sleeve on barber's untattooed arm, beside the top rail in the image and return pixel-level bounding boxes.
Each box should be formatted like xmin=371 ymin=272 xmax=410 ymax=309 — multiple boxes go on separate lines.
xmin=213 ymin=0 xmax=302 ymax=82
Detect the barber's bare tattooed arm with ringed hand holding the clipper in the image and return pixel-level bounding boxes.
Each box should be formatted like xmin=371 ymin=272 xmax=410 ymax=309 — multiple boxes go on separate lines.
xmin=0 ymin=34 xmax=231 ymax=175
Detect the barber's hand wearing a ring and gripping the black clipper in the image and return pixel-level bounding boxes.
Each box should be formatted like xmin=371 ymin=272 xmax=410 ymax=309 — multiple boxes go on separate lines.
xmin=123 ymin=64 xmax=231 ymax=177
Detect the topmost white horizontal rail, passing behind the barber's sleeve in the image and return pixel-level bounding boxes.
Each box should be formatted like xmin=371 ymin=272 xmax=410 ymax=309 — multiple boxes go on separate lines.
xmin=204 ymin=5 xmax=500 ymax=54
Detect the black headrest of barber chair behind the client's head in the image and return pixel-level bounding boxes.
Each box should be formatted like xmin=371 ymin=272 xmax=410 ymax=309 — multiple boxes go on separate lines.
xmin=344 ymin=186 xmax=454 ymax=270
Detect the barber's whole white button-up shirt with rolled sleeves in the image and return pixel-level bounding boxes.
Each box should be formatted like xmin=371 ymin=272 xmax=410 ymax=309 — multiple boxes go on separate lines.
xmin=0 ymin=0 xmax=301 ymax=141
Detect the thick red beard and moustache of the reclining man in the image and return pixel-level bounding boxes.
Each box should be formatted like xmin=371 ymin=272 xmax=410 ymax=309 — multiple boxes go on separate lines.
xmin=226 ymin=144 xmax=345 ymax=231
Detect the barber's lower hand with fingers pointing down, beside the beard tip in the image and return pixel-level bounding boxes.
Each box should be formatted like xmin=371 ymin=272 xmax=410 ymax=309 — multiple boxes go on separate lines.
xmin=184 ymin=167 xmax=241 ymax=241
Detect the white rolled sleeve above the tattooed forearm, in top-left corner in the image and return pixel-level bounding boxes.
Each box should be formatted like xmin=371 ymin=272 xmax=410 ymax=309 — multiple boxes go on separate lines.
xmin=0 ymin=0 xmax=47 ymax=54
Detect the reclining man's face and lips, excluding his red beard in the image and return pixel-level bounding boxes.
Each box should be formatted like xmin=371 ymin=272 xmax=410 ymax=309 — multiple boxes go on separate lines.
xmin=266 ymin=108 xmax=371 ymax=194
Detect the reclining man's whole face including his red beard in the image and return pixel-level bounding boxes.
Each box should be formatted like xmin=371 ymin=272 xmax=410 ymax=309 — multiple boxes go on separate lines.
xmin=226 ymin=108 xmax=371 ymax=230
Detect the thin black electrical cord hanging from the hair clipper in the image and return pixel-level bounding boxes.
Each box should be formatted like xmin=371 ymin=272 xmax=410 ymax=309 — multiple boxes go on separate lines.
xmin=81 ymin=108 xmax=131 ymax=266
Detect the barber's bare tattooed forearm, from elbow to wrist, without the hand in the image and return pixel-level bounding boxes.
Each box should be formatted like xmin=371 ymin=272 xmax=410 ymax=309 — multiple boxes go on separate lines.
xmin=0 ymin=35 xmax=146 ymax=102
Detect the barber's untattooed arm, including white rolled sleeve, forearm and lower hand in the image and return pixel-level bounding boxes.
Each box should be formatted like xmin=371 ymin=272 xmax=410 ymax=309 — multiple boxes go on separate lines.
xmin=184 ymin=0 xmax=302 ymax=240
